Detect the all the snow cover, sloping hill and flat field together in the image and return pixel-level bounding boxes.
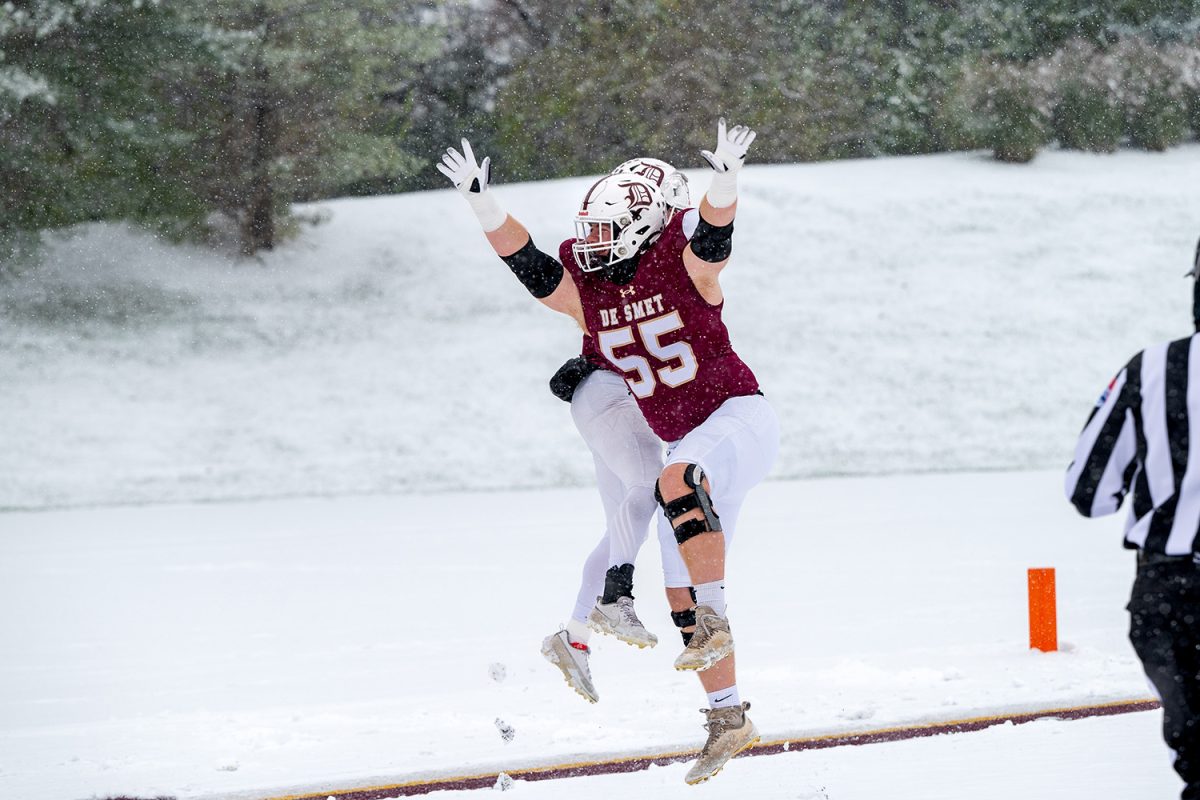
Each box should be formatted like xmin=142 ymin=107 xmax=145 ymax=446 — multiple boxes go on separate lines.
xmin=0 ymin=145 xmax=1200 ymax=800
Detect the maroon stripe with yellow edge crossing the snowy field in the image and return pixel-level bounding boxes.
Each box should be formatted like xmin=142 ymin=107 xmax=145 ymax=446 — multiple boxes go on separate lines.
xmin=268 ymin=699 xmax=1158 ymax=800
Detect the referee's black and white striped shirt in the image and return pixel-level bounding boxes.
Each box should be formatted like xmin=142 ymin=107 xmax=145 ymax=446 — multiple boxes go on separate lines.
xmin=1066 ymin=333 xmax=1200 ymax=555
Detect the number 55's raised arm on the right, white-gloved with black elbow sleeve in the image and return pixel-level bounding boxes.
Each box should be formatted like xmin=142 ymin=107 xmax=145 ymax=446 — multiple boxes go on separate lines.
xmin=683 ymin=118 xmax=755 ymax=305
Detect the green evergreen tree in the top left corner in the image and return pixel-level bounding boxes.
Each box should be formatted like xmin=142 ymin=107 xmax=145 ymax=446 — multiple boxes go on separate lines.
xmin=0 ymin=0 xmax=206 ymax=259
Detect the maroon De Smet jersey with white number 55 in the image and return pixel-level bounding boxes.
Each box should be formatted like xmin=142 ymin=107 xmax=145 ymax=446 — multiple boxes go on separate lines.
xmin=558 ymin=211 xmax=758 ymax=441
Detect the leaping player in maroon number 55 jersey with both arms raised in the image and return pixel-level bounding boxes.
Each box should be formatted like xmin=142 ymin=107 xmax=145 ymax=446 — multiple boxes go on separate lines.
xmin=438 ymin=119 xmax=779 ymax=783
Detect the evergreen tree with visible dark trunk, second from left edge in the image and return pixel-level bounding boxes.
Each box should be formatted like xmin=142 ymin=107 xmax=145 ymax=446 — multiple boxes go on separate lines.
xmin=180 ymin=0 xmax=437 ymax=254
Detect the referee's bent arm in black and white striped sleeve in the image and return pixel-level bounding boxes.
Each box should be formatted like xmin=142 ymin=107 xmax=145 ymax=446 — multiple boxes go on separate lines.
xmin=1066 ymin=362 xmax=1141 ymax=517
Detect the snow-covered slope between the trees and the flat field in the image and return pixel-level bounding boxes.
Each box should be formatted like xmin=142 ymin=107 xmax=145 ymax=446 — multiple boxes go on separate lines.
xmin=0 ymin=145 xmax=1200 ymax=509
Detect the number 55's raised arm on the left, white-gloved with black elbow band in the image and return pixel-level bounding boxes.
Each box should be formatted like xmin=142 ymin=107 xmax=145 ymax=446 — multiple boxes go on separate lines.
xmin=437 ymin=139 xmax=587 ymax=330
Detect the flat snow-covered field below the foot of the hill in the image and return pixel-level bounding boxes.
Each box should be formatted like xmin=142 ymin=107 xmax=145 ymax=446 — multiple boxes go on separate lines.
xmin=0 ymin=471 xmax=1175 ymax=800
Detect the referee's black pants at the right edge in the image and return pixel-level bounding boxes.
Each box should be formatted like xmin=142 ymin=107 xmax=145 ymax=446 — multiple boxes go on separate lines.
xmin=1128 ymin=559 xmax=1200 ymax=800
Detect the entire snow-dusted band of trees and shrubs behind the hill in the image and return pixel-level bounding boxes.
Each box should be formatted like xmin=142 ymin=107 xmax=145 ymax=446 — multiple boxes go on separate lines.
xmin=0 ymin=0 xmax=1200 ymax=260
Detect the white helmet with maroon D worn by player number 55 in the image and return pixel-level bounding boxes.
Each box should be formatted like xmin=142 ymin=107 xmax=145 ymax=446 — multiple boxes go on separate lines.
xmin=571 ymin=173 xmax=667 ymax=272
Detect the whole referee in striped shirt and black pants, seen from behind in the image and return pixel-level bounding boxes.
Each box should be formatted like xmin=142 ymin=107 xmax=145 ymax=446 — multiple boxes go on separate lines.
xmin=1066 ymin=243 xmax=1200 ymax=800
